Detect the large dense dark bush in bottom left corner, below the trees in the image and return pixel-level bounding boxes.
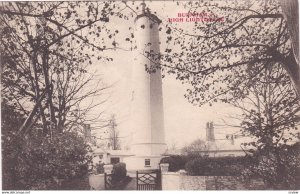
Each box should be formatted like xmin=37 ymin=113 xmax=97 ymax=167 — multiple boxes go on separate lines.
xmin=3 ymin=131 xmax=90 ymax=190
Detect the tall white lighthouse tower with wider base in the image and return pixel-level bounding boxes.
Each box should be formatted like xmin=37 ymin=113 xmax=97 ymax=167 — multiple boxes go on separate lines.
xmin=124 ymin=3 xmax=167 ymax=170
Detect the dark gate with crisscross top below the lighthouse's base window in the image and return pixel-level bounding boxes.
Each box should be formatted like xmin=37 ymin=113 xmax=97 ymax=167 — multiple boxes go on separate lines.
xmin=136 ymin=170 xmax=161 ymax=190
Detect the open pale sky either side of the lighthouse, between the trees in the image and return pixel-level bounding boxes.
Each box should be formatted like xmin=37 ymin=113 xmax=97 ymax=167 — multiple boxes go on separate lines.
xmin=84 ymin=1 xmax=246 ymax=147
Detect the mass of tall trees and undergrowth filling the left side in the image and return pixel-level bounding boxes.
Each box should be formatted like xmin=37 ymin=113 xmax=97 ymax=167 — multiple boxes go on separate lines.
xmin=0 ymin=2 xmax=131 ymax=190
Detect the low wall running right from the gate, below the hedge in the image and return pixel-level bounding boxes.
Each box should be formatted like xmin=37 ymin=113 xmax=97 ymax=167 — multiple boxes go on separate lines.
xmin=162 ymin=172 xmax=266 ymax=190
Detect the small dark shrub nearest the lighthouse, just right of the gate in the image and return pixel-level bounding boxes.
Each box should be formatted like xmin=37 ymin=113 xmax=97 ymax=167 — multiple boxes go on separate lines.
xmin=160 ymin=155 xmax=187 ymax=172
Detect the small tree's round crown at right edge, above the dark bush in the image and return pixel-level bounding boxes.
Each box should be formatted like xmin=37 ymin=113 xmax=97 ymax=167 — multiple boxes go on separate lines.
xmin=228 ymin=64 xmax=300 ymax=150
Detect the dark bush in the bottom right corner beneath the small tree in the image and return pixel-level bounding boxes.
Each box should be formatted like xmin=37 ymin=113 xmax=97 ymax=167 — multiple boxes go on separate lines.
xmin=243 ymin=143 xmax=300 ymax=190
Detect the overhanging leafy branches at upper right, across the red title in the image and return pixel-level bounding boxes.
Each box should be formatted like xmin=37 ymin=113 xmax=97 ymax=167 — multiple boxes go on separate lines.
xmin=154 ymin=1 xmax=299 ymax=105
